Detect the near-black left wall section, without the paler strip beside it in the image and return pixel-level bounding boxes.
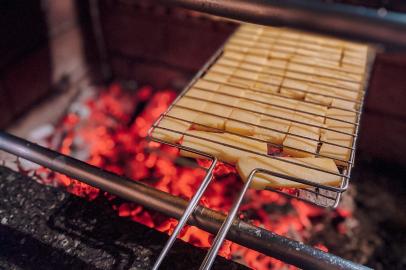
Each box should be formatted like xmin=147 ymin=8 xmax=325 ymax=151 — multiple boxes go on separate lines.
xmin=0 ymin=0 xmax=51 ymax=128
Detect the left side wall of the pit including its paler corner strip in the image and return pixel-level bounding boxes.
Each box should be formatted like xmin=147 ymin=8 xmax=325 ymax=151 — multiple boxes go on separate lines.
xmin=0 ymin=0 xmax=83 ymax=128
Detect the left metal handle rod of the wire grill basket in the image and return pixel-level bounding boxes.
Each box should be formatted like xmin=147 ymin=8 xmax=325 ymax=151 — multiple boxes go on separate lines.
xmin=152 ymin=158 xmax=217 ymax=270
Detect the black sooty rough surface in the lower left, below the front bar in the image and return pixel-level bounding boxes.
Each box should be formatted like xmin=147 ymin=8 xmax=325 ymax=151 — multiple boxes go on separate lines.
xmin=0 ymin=167 xmax=246 ymax=270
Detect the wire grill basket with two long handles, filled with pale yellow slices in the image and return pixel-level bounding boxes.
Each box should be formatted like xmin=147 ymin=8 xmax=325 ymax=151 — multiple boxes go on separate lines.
xmin=149 ymin=24 xmax=374 ymax=269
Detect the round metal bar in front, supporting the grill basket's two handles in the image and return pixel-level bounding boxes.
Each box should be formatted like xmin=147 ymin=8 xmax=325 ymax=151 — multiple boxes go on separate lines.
xmin=0 ymin=131 xmax=369 ymax=270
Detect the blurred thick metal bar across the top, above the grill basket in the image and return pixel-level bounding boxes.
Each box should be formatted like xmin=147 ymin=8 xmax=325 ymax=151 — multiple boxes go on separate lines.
xmin=156 ymin=0 xmax=406 ymax=48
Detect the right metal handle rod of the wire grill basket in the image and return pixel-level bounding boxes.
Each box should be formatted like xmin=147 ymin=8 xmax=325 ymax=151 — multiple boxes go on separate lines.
xmin=200 ymin=170 xmax=256 ymax=270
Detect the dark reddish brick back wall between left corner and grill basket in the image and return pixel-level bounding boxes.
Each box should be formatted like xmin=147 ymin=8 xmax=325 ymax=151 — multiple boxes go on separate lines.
xmin=101 ymin=0 xmax=235 ymax=88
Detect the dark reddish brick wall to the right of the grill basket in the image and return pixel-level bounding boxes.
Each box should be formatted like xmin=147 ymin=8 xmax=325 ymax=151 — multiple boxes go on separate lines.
xmin=359 ymin=53 xmax=406 ymax=165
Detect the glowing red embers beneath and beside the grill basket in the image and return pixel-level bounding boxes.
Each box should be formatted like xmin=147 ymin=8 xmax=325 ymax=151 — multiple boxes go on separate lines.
xmin=31 ymin=85 xmax=351 ymax=269
